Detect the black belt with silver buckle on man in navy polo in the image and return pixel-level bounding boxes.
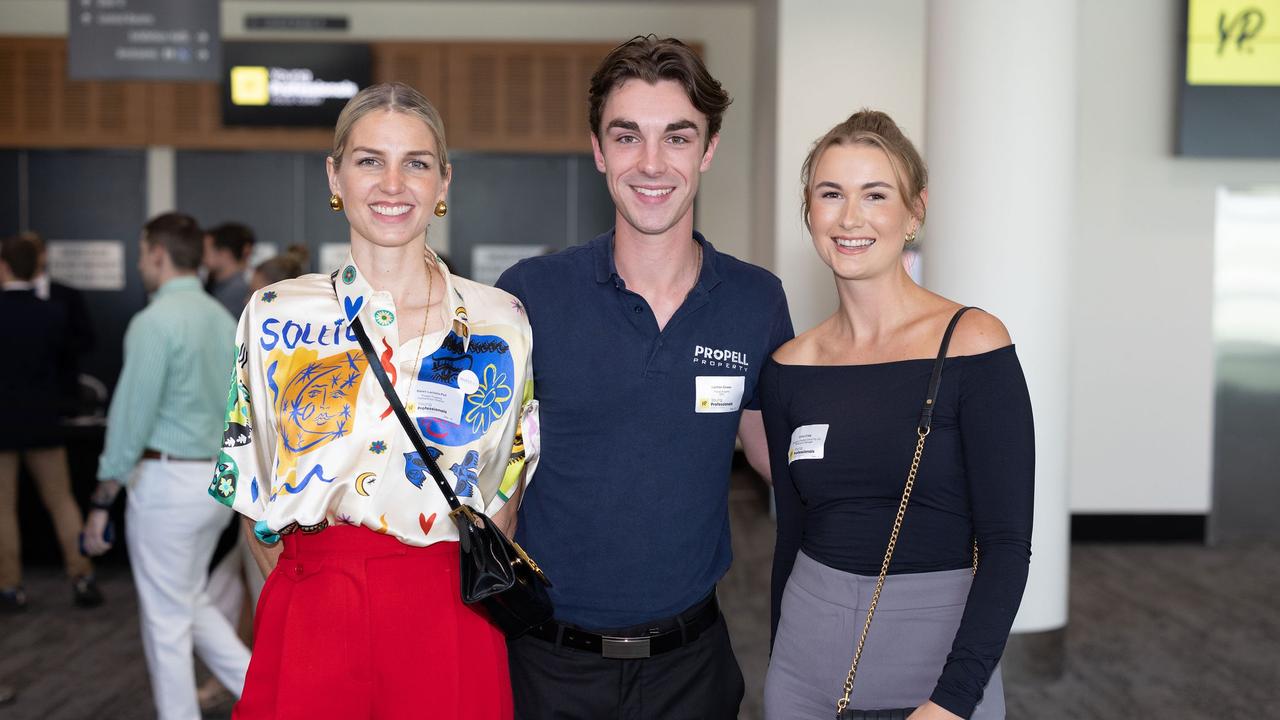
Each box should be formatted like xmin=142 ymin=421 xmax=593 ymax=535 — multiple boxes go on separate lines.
xmin=529 ymin=593 xmax=719 ymax=660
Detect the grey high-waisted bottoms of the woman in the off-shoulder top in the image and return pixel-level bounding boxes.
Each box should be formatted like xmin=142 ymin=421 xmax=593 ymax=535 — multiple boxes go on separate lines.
xmin=764 ymin=552 xmax=1005 ymax=720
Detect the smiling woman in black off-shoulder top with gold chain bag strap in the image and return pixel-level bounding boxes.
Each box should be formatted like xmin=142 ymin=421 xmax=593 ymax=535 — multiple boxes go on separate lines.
xmin=760 ymin=110 xmax=1034 ymax=720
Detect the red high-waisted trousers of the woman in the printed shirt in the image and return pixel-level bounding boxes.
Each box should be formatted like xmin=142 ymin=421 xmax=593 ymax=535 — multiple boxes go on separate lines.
xmin=233 ymin=525 xmax=512 ymax=720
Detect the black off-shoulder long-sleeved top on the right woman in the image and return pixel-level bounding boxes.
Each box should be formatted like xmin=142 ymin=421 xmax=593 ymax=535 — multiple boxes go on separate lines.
xmin=760 ymin=346 xmax=1036 ymax=717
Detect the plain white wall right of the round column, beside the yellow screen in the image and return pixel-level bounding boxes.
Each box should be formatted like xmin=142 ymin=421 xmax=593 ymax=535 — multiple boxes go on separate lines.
xmin=1070 ymin=0 xmax=1280 ymax=512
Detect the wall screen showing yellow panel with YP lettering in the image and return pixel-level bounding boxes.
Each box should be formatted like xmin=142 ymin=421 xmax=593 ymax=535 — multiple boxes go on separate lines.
xmin=1178 ymin=0 xmax=1280 ymax=158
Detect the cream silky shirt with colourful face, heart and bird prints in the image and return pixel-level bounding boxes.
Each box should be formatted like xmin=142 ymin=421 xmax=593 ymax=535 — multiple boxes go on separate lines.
xmin=209 ymin=252 xmax=539 ymax=546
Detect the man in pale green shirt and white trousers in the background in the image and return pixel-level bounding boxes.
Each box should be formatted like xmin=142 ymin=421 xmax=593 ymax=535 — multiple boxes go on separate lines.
xmin=84 ymin=213 xmax=248 ymax=720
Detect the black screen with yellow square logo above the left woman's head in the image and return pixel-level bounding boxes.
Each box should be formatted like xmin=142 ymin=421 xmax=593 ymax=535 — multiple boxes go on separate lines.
xmin=223 ymin=42 xmax=370 ymax=127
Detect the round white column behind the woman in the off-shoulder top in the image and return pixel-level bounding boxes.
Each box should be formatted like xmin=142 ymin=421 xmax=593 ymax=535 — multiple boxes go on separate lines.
xmin=923 ymin=0 xmax=1076 ymax=633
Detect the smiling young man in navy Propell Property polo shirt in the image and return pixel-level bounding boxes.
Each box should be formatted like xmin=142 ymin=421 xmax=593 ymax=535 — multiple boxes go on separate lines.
xmin=498 ymin=36 xmax=792 ymax=720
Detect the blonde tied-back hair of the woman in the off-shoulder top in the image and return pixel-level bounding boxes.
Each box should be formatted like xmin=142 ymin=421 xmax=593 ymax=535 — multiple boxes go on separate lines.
xmin=800 ymin=109 xmax=929 ymax=224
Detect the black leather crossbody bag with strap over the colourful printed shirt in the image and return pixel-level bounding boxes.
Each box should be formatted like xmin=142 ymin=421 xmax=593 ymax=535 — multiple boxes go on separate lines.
xmin=351 ymin=311 xmax=553 ymax=638
